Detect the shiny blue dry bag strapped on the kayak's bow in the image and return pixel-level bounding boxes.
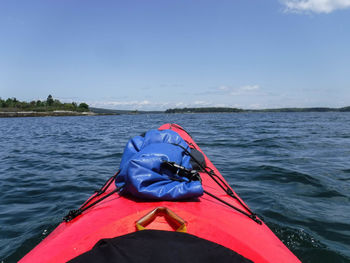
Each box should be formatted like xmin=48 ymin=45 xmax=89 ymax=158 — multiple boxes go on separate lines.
xmin=116 ymin=130 xmax=203 ymax=200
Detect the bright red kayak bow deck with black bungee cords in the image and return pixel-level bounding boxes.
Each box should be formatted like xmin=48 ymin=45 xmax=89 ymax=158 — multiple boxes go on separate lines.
xmin=20 ymin=124 xmax=300 ymax=263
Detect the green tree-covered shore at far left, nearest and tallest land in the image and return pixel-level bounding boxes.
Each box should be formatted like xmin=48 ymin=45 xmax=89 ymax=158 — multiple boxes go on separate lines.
xmin=0 ymin=95 xmax=89 ymax=112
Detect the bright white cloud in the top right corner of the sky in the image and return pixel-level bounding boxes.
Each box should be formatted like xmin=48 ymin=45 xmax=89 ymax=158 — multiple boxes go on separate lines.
xmin=283 ymin=0 xmax=350 ymax=14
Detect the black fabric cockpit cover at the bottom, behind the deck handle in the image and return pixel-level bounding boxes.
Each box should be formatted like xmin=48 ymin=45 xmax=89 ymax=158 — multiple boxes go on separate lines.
xmin=69 ymin=230 xmax=252 ymax=263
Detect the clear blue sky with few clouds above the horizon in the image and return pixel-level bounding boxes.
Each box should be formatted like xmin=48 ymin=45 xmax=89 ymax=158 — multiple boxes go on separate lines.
xmin=0 ymin=0 xmax=350 ymax=110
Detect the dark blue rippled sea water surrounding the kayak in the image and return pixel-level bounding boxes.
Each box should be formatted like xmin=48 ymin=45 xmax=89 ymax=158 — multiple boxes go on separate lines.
xmin=0 ymin=113 xmax=350 ymax=263
